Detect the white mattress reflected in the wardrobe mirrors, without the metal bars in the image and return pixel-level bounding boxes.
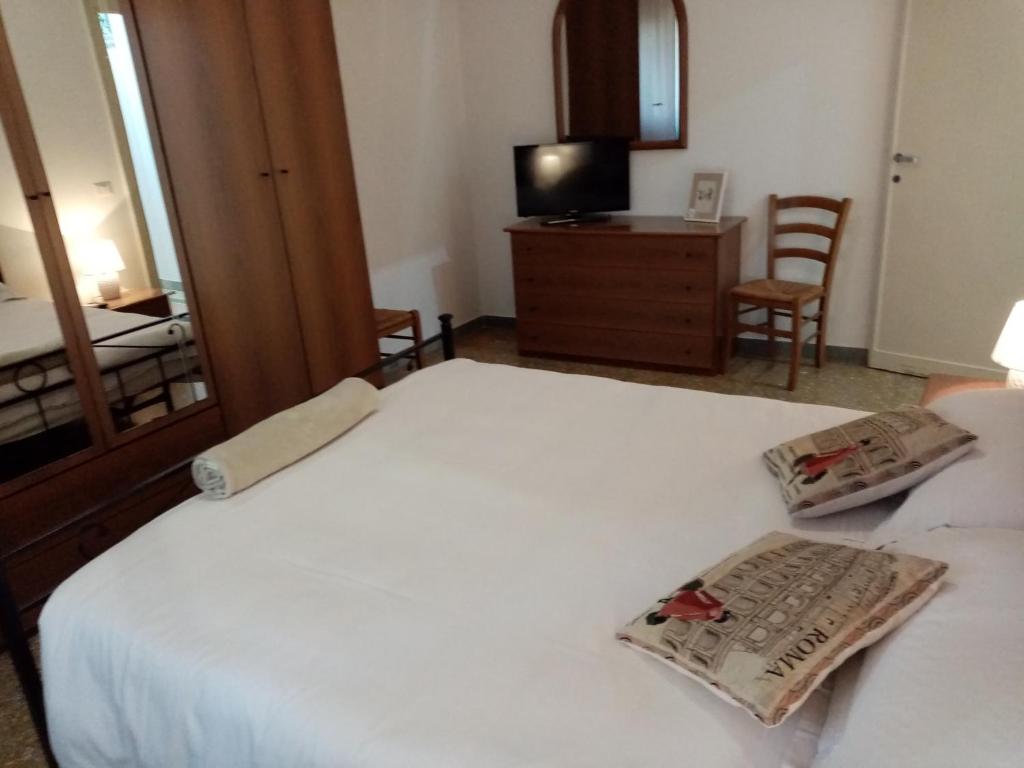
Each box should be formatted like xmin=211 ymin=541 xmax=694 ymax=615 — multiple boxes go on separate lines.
xmin=0 ymin=299 xmax=197 ymax=443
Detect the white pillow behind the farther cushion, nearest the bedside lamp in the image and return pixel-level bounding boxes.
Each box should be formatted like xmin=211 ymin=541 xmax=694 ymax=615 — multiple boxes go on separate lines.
xmin=871 ymin=389 xmax=1024 ymax=544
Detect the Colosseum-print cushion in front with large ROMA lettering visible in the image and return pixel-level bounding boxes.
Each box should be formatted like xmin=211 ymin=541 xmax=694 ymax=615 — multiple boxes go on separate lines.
xmin=617 ymin=532 xmax=946 ymax=727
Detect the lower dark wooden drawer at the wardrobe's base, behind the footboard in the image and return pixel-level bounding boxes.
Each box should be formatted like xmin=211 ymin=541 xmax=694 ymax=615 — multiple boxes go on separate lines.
xmin=5 ymin=467 xmax=198 ymax=608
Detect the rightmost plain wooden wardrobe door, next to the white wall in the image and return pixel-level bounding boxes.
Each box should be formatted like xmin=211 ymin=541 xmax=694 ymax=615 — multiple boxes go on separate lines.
xmin=246 ymin=0 xmax=378 ymax=392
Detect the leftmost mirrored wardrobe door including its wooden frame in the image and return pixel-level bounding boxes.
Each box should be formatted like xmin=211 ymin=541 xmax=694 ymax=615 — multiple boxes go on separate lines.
xmin=0 ymin=25 xmax=101 ymax=487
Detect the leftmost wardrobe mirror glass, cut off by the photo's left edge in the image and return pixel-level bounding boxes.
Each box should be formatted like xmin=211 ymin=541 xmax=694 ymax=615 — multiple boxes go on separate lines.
xmin=0 ymin=109 xmax=91 ymax=483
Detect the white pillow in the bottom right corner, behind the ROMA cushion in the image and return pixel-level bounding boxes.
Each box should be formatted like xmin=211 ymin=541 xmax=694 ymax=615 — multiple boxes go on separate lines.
xmin=814 ymin=528 xmax=1024 ymax=768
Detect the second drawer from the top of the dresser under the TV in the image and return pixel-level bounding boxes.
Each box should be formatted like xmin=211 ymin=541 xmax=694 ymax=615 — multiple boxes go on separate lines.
xmin=515 ymin=262 xmax=715 ymax=304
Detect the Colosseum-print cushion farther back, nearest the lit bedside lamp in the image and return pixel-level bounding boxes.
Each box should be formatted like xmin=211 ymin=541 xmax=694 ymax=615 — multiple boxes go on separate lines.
xmin=764 ymin=406 xmax=977 ymax=517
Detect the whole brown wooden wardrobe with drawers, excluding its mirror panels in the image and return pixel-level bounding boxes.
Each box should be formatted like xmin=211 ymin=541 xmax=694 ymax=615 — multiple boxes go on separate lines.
xmin=0 ymin=0 xmax=378 ymax=638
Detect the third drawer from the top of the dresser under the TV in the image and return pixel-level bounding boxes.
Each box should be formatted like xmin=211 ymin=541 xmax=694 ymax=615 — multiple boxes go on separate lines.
xmin=516 ymin=288 xmax=715 ymax=336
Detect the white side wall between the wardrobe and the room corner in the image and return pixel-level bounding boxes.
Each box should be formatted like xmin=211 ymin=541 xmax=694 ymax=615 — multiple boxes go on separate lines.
xmin=332 ymin=0 xmax=480 ymax=335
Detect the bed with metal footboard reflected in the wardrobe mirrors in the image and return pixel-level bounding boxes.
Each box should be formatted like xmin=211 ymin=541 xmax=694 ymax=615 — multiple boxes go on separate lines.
xmin=0 ymin=298 xmax=198 ymax=445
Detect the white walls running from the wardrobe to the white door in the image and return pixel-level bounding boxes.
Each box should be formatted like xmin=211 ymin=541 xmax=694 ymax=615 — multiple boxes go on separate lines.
xmin=334 ymin=0 xmax=903 ymax=347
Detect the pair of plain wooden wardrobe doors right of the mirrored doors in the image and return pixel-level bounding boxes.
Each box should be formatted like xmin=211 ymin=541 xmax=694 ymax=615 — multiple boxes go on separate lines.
xmin=133 ymin=0 xmax=377 ymax=433
